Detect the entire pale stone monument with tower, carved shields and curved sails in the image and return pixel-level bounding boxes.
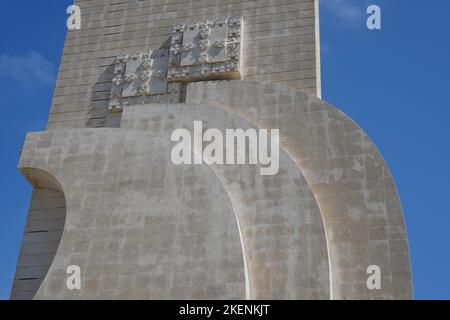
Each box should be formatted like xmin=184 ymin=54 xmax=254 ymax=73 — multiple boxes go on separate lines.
xmin=11 ymin=0 xmax=412 ymax=299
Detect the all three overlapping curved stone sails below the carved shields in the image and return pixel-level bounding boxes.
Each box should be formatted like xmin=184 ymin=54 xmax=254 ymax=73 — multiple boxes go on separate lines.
xmin=14 ymin=81 xmax=412 ymax=299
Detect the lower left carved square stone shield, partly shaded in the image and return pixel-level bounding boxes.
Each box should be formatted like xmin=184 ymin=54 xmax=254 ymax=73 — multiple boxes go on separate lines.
xmin=108 ymin=49 xmax=181 ymax=113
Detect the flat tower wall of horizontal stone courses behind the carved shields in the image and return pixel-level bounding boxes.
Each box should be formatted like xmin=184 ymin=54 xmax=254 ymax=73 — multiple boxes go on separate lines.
xmin=48 ymin=0 xmax=320 ymax=129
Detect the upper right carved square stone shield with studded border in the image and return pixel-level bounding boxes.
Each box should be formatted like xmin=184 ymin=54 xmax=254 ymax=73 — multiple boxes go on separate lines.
xmin=167 ymin=18 xmax=243 ymax=81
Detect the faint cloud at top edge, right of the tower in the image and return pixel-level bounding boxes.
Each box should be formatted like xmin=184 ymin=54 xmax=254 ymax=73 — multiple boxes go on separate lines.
xmin=320 ymin=0 xmax=367 ymax=25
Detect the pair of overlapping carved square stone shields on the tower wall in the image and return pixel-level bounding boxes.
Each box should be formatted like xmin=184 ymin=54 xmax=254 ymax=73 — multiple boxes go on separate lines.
xmin=108 ymin=18 xmax=243 ymax=113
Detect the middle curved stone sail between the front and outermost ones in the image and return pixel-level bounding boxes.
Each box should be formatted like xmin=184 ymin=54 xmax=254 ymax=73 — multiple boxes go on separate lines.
xmin=122 ymin=104 xmax=330 ymax=299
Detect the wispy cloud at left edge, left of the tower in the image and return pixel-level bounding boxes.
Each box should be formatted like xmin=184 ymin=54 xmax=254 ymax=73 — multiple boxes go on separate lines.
xmin=0 ymin=51 xmax=56 ymax=85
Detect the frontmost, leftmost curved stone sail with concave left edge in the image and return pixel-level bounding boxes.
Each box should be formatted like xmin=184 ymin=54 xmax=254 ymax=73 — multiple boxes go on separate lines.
xmin=20 ymin=129 xmax=245 ymax=299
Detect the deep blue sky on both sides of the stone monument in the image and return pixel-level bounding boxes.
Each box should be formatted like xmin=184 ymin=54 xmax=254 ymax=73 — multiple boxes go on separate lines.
xmin=0 ymin=0 xmax=450 ymax=299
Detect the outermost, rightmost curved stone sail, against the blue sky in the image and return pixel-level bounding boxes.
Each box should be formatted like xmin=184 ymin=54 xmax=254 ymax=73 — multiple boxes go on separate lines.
xmin=186 ymin=81 xmax=412 ymax=299
